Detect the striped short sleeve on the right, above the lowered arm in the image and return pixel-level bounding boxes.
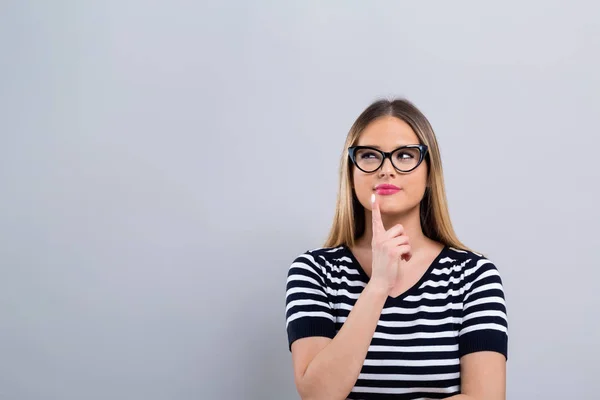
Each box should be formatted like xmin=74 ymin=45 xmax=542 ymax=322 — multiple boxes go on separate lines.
xmin=459 ymin=259 xmax=508 ymax=359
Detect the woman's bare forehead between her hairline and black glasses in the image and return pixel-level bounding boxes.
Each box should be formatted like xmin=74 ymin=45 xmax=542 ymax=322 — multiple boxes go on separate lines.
xmin=357 ymin=116 xmax=419 ymax=150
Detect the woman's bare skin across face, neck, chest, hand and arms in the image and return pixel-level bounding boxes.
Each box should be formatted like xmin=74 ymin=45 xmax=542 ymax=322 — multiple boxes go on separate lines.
xmin=292 ymin=117 xmax=506 ymax=400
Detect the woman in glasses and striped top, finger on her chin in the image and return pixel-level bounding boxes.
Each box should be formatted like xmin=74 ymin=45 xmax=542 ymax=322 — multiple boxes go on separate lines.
xmin=286 ymin=100 xmax=508 ymax=400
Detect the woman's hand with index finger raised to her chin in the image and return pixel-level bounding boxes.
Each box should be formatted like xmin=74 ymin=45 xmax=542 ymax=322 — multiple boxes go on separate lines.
xmin=371 ymin=194 xmax=412 ymax=292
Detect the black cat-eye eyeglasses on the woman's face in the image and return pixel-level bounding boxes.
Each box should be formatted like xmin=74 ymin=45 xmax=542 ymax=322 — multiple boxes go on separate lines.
xmin=348 ymin=144 xmax=428 ymax=173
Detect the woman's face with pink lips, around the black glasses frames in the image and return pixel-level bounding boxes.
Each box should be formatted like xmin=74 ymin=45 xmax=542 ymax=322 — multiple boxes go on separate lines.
xmin=352 ymin=116 xmax=427 ymax=214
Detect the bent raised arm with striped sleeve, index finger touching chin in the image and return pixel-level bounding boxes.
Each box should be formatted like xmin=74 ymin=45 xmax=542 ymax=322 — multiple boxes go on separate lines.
xmin=287 ymin=195 xmax=411 ymax=400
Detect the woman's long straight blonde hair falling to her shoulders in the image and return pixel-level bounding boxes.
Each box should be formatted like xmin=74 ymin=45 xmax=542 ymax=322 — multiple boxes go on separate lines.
xmin=324 ymin=99 xmax=472 ymax=251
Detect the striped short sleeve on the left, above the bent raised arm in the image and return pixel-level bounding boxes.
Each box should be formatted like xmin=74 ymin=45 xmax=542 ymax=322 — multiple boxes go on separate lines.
xmin=285 ymin=252 xmax=335 ymax=350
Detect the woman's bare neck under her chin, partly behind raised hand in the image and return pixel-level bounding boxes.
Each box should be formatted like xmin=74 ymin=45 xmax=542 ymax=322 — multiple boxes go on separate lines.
xmin=356 ymin=207 xmax=432 ymax=254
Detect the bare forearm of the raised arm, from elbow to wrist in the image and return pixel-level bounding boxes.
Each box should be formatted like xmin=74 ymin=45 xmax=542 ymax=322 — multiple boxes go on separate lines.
xmin=300 ymin=283 xmax=387 ymax=400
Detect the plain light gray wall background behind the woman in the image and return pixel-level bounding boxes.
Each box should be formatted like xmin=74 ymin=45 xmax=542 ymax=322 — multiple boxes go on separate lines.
xmin=0 ymin=0 xmax=600 ymax=400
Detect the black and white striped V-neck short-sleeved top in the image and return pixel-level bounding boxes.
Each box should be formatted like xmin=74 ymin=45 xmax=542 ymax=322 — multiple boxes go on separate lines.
xmin=286 ymin=245 xmax=508 ymax=400
